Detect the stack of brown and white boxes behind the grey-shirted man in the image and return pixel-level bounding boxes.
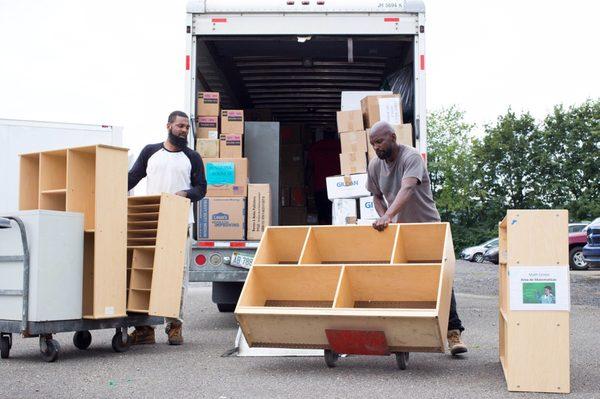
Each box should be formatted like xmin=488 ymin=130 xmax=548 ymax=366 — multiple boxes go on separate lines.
xmin=327 ymin=94 xmax=413 ymax=225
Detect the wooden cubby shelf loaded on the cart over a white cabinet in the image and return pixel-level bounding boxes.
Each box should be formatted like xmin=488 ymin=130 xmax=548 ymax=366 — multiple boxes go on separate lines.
xmin=19 ymin=145 xmax=127 ymax=319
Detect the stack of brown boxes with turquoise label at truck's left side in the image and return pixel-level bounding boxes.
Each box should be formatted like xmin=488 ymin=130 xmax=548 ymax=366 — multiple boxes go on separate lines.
xmin=196 ymin=92 xmax=271 ymax=240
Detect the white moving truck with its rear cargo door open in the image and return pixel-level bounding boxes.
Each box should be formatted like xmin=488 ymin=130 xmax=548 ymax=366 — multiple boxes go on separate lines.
xmin=185 ymin=0 xmax=427 ymax=311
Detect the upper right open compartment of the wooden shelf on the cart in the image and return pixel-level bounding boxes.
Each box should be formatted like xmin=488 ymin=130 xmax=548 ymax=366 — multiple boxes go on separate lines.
xmin=66 ymin=150 xmax=96 ymax=230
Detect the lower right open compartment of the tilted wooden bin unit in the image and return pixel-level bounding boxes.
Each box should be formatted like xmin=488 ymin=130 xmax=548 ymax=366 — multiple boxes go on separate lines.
xmin=334 ymin=264 xmax=441 ymax=310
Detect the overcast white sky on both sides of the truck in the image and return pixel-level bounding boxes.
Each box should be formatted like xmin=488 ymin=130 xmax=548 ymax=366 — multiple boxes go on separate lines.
xmin=0 ymin=0 xmax=600 ymax=152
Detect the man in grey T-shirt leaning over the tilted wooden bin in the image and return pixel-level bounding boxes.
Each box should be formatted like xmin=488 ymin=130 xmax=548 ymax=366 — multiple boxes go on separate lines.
xmin=367 ymin=121 xmax=467 ymax=355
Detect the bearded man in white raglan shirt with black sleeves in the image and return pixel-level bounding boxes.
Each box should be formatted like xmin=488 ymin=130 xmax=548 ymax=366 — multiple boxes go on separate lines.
xmin=128 ymin=111 xmax=206 ymax=345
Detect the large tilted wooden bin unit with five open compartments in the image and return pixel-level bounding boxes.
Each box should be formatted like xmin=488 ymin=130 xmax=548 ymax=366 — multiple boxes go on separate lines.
xmin=235 ymin=223 xmax=454 ymax=352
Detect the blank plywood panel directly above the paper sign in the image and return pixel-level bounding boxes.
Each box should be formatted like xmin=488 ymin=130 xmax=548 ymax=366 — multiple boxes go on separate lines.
xmin=506 ymin=210 xmax=569 ymax=266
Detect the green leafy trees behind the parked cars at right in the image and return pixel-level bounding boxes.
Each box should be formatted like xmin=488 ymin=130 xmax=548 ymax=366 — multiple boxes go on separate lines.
xmin=427 ymin=100 xmax=600 ymax=251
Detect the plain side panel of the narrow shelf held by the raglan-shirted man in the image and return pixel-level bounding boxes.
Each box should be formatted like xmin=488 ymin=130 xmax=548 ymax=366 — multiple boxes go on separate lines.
xmin=149 ymin=194 xmax=190 ymax=317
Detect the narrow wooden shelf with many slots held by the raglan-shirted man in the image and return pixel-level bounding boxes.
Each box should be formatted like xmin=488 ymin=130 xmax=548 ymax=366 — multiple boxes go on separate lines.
xmin=127 ymin=194 xmax=190 ymax=317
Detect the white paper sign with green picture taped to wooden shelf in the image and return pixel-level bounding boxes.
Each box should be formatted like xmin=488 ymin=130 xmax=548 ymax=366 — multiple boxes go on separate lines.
xmin=508 ymin=266 xmax=571 ymax=311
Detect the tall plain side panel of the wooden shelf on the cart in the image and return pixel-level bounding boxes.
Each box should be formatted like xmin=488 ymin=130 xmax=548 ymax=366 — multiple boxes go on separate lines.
xmin=92 ymin=146 xmax=127 ymax=318
